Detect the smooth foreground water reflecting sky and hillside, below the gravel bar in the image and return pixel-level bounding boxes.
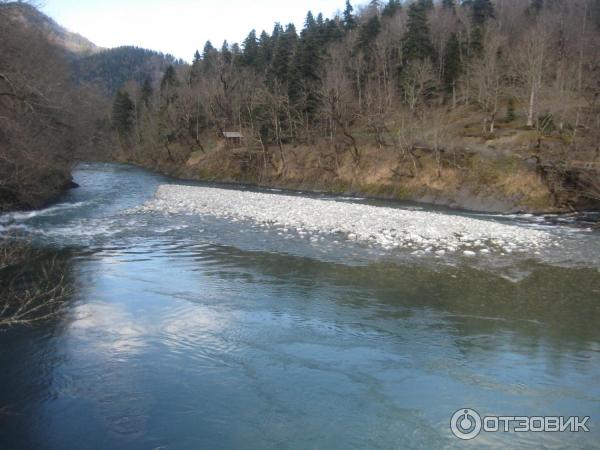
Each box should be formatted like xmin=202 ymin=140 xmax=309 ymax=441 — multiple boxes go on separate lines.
xmin=0 ymin=245 xmax=600 ymax=448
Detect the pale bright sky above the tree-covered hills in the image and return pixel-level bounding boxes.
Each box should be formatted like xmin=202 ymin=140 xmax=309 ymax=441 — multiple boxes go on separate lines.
xmin=41 ymin=0 xmax=346 ymax=61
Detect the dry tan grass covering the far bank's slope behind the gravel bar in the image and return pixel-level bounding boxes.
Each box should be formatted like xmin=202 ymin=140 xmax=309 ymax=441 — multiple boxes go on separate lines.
xmin=165 ymin=132 xmax=564 ymax=212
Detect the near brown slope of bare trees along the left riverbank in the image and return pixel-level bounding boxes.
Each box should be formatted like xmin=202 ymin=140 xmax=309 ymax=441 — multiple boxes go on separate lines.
xmin=0 ymin=3 xmax=110 ymax=210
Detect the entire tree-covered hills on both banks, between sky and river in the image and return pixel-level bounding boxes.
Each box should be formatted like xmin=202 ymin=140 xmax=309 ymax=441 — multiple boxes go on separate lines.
xmin=0 ymin=0 xmax=600 ymax=211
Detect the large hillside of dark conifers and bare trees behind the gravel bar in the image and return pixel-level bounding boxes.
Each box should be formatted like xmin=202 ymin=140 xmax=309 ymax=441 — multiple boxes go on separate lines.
xmin=113 ymin=0 xmax=600 ymax=210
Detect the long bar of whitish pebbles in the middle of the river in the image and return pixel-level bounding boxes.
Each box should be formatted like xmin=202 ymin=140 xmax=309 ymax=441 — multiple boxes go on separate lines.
xmin=132 ymin=185 xmax=557 ymax=256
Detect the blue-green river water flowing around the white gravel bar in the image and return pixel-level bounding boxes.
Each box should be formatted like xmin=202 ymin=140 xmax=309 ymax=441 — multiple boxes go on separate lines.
xmin=0 ymin=164 xmax=600 ymax=450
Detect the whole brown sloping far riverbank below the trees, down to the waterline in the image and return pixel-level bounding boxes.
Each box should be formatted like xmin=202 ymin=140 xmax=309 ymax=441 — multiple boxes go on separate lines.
xmin=116 ymin=143 xmax=592 ymax=213
